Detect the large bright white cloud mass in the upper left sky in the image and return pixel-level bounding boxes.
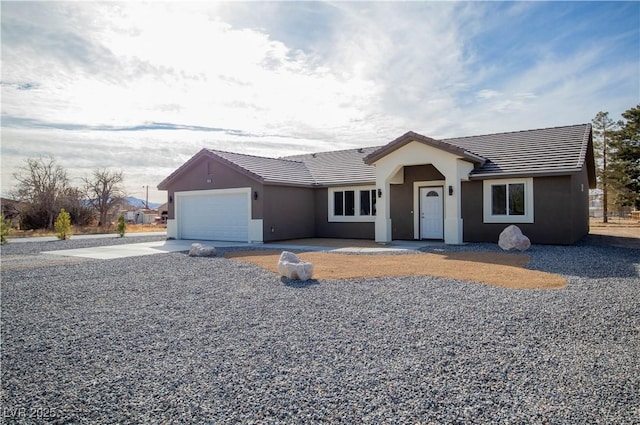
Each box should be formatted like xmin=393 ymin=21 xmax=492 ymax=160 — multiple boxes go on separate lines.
xmin=4 ymin=3 xmax=375 ymax=132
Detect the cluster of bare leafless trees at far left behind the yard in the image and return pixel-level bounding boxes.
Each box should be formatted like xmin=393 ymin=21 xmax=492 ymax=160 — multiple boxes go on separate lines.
xmin=10 ymin=156 xmax=126 ymax=230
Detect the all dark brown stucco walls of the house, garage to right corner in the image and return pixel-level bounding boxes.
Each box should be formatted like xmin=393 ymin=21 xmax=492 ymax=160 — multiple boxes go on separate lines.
xmin=167 ymin=152 xmax=589 ymax=244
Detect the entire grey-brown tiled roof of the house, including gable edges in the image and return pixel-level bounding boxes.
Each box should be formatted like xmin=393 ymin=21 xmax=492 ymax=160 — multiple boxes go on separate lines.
xmin=159 ymin=124 xmax=595 ymax=187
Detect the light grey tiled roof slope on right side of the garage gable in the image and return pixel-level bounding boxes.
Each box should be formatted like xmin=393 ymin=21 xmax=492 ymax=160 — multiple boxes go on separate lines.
xmin=207 ymin=149 xmax=315 ymax=185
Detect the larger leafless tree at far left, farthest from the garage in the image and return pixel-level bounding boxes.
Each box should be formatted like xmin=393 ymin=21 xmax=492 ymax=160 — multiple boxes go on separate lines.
xmin=12 ymin=156 xmax=69 ymax=229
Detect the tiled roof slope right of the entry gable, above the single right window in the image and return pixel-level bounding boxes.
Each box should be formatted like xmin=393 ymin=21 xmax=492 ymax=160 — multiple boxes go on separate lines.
xmin=442 ymin=124 xmax=591 ymax=177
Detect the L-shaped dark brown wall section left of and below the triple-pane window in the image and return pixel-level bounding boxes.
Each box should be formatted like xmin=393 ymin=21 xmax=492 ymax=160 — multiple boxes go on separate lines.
xmin=314 ymin=188 xmax=375 ymax=239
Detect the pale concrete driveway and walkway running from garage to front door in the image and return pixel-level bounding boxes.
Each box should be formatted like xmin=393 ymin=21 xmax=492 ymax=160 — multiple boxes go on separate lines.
xmin=43 ymin=235 xmax=440 ymax=260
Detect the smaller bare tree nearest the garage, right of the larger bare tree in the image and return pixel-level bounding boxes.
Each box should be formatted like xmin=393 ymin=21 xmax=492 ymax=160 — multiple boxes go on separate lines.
xmin=83 ymin=168 xmax=126 ymax=226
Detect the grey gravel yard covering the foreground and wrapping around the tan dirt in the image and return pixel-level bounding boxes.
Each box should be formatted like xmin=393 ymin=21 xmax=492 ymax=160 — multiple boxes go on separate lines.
xmin=1 ymin=238 xmax=640 ymax=424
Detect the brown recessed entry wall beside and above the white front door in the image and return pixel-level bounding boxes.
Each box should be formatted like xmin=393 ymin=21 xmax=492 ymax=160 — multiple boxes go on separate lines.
xmin=390 ymin=164 xmax=445 ymax=240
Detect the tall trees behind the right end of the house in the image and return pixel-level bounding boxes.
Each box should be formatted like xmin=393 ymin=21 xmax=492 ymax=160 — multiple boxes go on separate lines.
xmin=591 ymin=105 xmax=640 ymax=223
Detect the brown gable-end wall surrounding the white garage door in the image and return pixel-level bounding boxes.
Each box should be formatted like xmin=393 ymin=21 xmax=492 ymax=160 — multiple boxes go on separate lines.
xmin=167 ymin=158 xmax=265 ymax=220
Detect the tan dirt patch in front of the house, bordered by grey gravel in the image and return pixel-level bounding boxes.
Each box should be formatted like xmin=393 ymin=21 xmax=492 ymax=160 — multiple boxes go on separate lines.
xmin=226 ymin=251 xmax=567 ymax=289
